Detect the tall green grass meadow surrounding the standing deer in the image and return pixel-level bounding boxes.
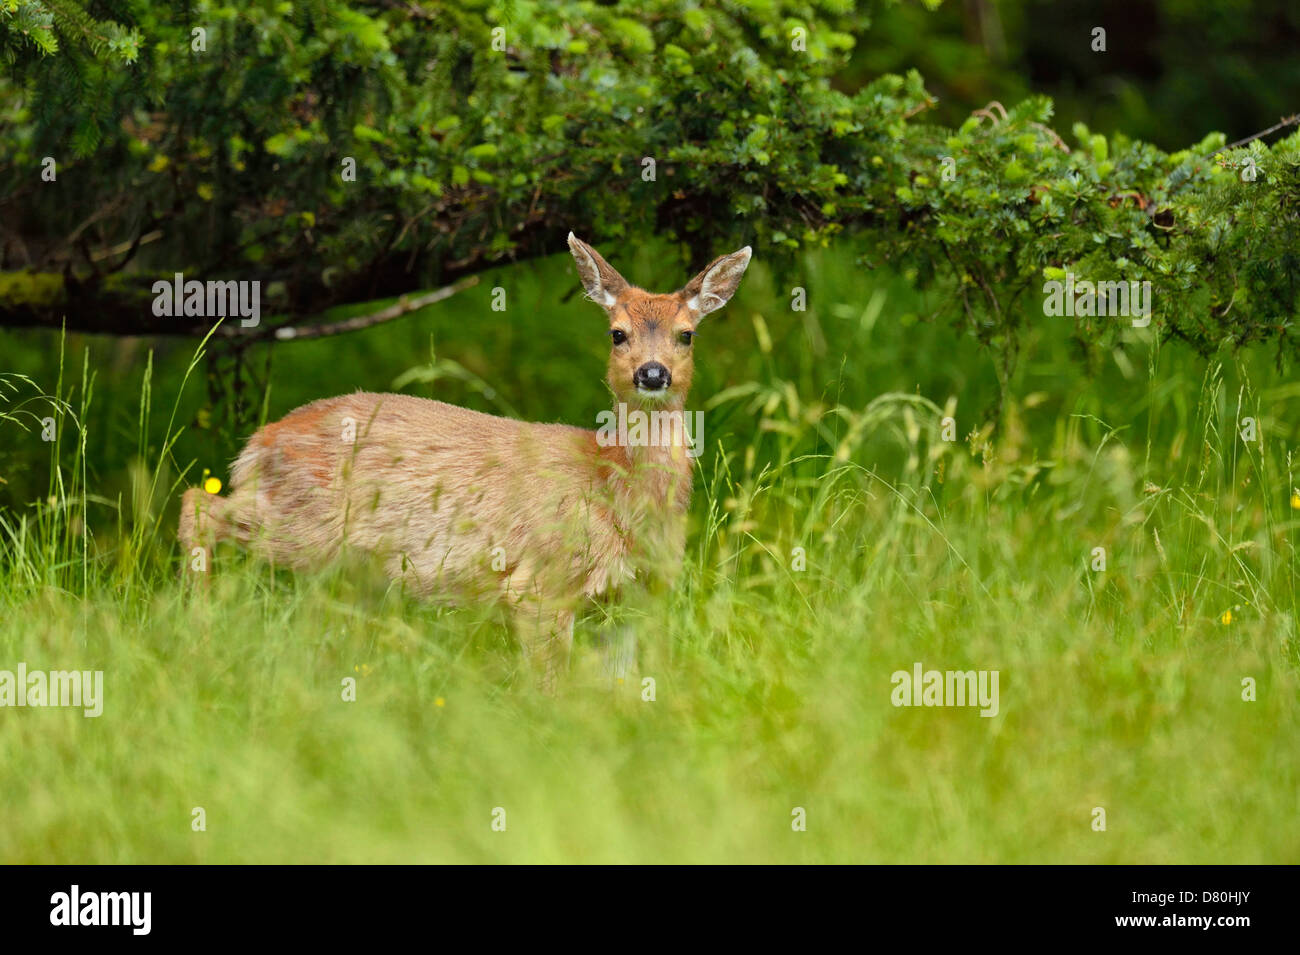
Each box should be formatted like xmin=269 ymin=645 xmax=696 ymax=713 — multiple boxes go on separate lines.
xmin=0 ymin=249 xmax=1300 ymax=863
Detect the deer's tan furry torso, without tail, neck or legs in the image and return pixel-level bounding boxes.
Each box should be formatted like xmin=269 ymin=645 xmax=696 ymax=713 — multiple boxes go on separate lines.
xmin=231 ymin=392 xmax=623 ymax=591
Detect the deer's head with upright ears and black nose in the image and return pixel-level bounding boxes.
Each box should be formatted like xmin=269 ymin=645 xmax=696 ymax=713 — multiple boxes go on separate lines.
xmin=568 ymin=233 xmax=751 ymax=408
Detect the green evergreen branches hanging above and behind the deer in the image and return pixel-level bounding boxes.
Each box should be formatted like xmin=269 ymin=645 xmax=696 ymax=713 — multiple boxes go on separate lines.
xmin=0 ymin=0 xmax=1300 ymax=361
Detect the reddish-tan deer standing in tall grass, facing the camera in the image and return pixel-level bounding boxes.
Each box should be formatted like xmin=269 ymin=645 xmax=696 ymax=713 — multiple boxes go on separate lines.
xmin=178 ymin=233 xmax=751 ymax=693
